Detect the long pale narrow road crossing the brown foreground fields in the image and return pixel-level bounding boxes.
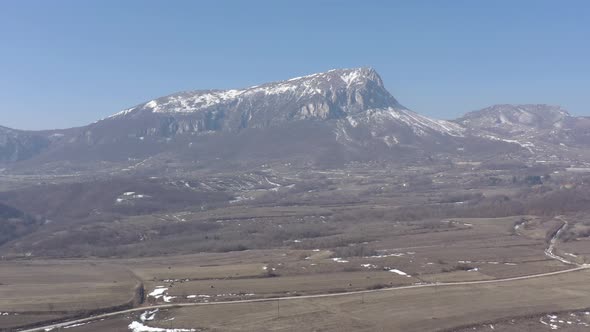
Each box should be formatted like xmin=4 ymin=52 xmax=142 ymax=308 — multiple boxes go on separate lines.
xmin=20 ymin=265 xmax=590 ymax=332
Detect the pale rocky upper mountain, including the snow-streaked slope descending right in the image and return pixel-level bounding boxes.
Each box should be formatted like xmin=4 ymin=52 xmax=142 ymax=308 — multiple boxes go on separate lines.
xmin=80 ymin=68 xmax=472 ymax=152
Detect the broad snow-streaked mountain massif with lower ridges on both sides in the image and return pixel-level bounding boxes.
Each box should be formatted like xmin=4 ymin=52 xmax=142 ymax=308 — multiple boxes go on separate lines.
xmin=0 ymin=68 xmax=569 ymax=171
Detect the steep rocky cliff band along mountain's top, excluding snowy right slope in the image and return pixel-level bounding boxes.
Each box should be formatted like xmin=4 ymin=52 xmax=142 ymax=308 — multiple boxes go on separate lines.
xmin=99 ymin=68 xmax=403 ymax=136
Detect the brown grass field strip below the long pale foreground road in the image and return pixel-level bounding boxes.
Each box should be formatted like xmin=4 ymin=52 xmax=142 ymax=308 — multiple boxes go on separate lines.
xmin=61 ymin=270 xmax=590 ymax=332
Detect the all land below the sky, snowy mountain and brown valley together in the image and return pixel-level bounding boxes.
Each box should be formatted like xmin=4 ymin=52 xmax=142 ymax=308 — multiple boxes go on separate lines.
xmin=0 ymin=68 xmax=590 ymax=332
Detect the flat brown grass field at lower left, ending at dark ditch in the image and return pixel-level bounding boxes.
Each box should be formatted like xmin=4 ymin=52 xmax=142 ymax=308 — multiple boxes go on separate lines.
xmin=0 ymin=261 xmax=140 ymax=329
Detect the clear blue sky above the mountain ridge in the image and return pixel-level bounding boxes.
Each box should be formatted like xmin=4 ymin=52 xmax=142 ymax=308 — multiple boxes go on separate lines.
xmin=0 ymin=0 xmax=590 ymax=129
